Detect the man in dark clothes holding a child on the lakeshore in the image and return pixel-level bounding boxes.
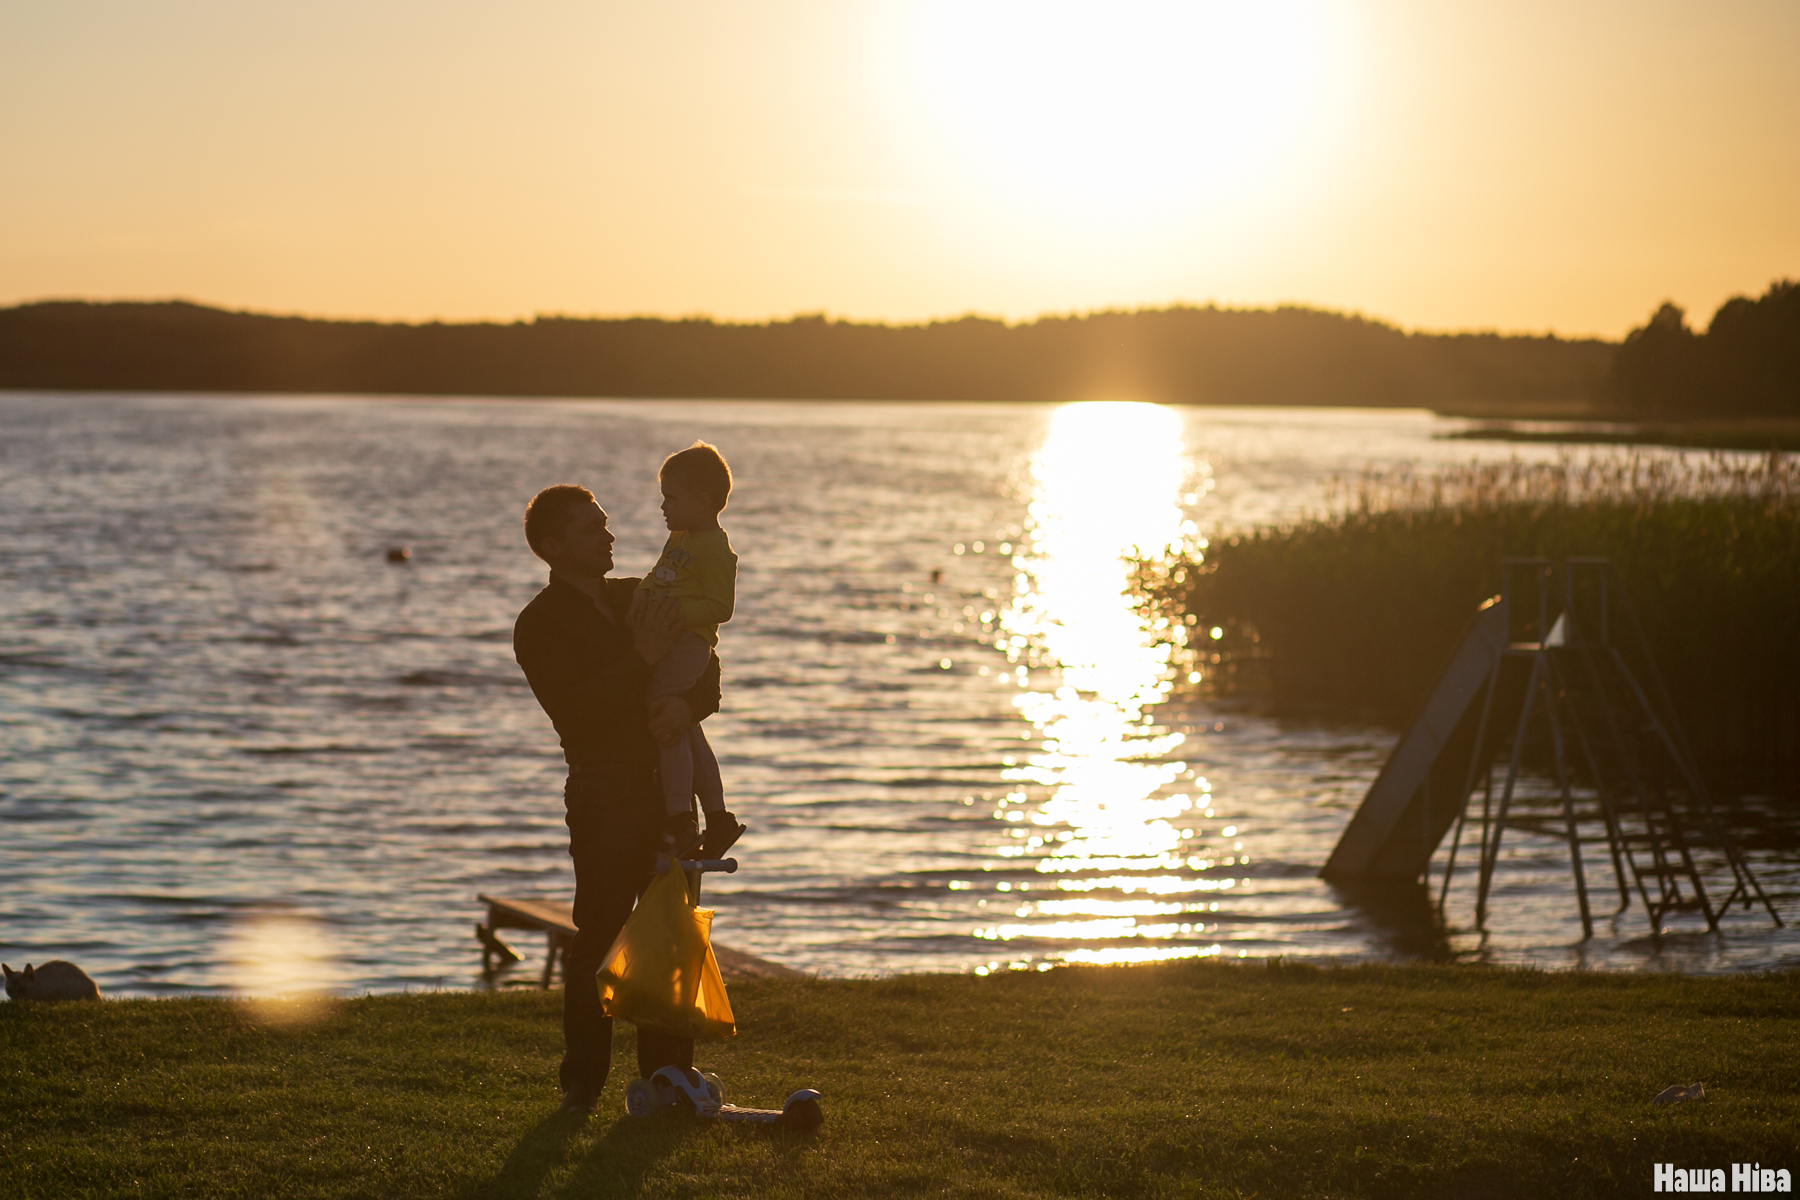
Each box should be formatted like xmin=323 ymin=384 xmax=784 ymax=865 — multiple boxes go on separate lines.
xmin=513 ymin=484 xmax=718 ymax=1114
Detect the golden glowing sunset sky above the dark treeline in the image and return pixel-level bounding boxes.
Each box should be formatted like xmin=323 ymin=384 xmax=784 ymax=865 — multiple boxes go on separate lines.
xmin=0 ymin=0 xmax=1800 ymax=336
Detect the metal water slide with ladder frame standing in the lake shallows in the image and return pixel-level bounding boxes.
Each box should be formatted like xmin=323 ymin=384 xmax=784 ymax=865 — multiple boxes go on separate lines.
xmin=1319 ymin=558 xmax=1782 ymax=937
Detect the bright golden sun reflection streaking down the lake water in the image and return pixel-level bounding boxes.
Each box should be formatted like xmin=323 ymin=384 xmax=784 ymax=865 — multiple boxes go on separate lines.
xmin=976 ymin=403 xmax=1235 ymax=973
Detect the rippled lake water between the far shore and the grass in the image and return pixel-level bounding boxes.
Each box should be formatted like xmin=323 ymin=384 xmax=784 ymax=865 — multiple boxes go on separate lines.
xmin=0 ymin=392 xmax=1800 ymax=995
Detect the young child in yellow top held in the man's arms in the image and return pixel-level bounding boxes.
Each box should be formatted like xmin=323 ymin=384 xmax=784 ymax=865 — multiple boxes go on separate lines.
xmin=637 ymin=441 xmax=745 ymax=858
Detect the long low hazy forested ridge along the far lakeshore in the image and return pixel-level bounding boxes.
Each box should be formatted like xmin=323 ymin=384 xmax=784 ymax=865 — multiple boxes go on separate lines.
xmin=0 ymin=302 xmax=1615 ymax=414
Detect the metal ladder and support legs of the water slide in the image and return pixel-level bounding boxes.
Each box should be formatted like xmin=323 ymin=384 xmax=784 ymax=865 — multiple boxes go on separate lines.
xmin=1438 ymin=558 xmax=1782 ymax=937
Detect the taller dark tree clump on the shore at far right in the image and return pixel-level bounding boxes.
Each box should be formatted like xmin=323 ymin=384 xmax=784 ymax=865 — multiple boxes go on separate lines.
xmin=1606 ymin=279 xmax=1800 ymax=419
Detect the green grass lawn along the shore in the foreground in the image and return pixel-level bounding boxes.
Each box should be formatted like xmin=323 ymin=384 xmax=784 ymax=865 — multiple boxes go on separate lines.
xmin=0 ymin=963 xmax=1800 ymax=1200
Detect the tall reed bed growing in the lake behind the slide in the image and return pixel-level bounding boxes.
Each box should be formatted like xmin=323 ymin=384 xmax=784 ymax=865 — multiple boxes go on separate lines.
xmin=1136 ymin=453 xmax=1800 ymax=801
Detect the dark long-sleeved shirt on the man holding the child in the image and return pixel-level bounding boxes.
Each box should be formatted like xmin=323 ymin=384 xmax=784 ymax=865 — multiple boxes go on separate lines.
xmin=513 ymin=576 xmax=720 ymax=766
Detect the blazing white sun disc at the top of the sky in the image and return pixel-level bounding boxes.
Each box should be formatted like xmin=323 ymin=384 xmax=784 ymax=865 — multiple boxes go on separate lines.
xmin=878 ymin=0 xmax=1350 ymax=230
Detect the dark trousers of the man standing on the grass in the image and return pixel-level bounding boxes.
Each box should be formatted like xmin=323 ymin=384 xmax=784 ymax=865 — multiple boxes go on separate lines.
xmin=560 ymin=766 xmax=693 ymax=1096
